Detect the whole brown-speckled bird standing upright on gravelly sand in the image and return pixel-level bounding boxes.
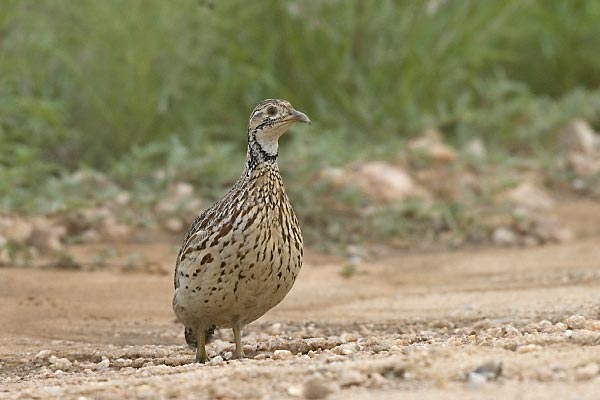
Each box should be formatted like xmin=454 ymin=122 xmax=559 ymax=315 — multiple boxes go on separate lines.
xmin=173 ymin=99 xmax=311 ymax=363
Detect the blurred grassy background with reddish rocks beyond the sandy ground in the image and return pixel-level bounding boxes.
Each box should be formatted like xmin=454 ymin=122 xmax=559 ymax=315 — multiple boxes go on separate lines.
xmin=0 ymin=0 xmax=600 ymax=272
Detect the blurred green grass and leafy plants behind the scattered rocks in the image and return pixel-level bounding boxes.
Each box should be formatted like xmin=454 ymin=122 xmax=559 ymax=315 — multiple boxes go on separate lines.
xmin=0 ymin=0 xmax=600 ymax=247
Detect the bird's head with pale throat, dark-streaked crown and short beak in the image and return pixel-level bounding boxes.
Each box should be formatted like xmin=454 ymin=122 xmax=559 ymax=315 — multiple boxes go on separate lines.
xmin=248 ymin=99 xmax=311 ymax=161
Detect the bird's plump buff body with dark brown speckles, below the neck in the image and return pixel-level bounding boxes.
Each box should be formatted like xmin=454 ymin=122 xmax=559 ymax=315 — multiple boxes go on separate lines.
xmin=173 ymin=164 xmax=303 ymax=328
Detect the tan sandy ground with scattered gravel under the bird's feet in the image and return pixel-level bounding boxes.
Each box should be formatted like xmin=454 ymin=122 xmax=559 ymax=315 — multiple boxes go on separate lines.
xmin=0 ymin=204 xmax=600 ymax=399
